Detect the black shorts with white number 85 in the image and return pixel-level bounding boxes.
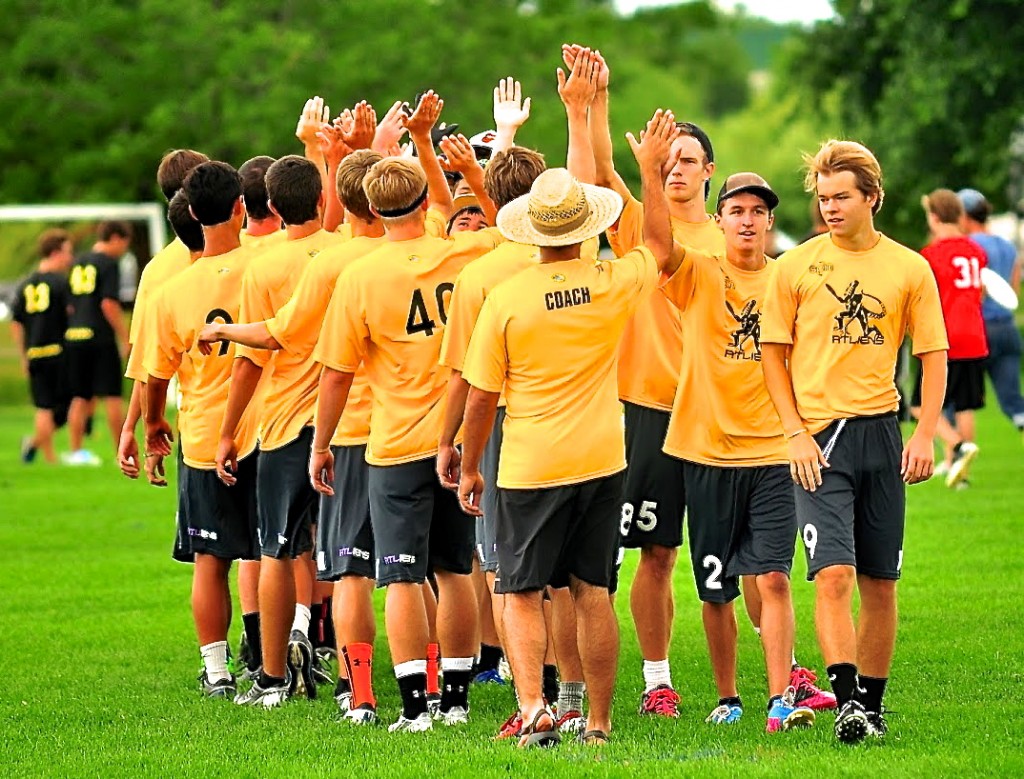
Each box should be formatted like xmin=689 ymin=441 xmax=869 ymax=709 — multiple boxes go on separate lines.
xmin=622 ymin=403 xmax=686 ymax=549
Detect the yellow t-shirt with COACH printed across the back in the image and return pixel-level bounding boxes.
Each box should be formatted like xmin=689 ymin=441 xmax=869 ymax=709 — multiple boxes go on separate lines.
xmin=463 ymin=248 xmax=658 ymax=489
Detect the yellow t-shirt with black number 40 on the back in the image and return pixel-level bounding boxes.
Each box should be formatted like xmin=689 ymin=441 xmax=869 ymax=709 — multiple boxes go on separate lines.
xmin=313 ymin=230 xmax=500 ymax=465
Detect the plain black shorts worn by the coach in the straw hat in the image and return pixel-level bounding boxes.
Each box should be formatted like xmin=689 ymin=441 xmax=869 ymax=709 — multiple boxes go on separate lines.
xmin=495 ymin=473 xmax=625 ymax=593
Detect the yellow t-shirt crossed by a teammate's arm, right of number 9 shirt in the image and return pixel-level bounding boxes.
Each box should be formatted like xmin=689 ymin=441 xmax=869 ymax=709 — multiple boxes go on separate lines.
xmin=236 ymin=230 xmax=341 ymax=451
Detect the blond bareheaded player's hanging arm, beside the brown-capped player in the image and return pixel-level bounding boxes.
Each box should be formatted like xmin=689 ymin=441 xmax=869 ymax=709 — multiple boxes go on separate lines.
xmin=761 ymin=342 xmax=828 ymax=492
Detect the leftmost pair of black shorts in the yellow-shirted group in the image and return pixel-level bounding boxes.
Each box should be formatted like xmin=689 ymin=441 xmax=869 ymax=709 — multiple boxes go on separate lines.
xmin=174 ymin=452 xmax=259 ymax=563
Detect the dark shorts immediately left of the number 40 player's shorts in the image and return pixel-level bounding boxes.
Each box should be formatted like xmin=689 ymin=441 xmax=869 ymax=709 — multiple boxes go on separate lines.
xmin=316 ymin=443 xmax=376 ymax=581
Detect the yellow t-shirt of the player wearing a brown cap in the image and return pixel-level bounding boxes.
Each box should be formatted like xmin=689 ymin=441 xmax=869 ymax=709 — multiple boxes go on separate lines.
xmin=662 ymin=249 xmax=788 ymax=467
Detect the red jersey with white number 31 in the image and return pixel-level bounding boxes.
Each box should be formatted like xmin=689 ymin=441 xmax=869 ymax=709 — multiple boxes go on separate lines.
xmin=921 ymin=235 xmax=988 ymax=359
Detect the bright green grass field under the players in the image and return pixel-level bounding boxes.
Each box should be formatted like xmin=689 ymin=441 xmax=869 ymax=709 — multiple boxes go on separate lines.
xmin=0 ymin=397 xmax=1024 ymax=777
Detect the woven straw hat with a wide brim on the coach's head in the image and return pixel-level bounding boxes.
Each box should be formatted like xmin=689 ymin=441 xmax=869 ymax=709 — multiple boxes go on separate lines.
xmin=498 ymin=168 xmax=623 ymax=247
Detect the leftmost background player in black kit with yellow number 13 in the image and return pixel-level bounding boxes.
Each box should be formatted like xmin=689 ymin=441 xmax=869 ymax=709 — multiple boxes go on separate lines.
xmin=11 ymin=229 xmax=73 ymax=463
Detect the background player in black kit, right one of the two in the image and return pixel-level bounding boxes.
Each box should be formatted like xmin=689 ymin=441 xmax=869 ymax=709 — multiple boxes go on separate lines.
xmin=65 ymin=221 xmax=131 ymax=465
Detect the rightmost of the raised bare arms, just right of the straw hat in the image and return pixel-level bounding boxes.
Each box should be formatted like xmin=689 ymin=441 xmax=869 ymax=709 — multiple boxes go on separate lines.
xmin=626 ymin=109 xmax=682 ymax=275
